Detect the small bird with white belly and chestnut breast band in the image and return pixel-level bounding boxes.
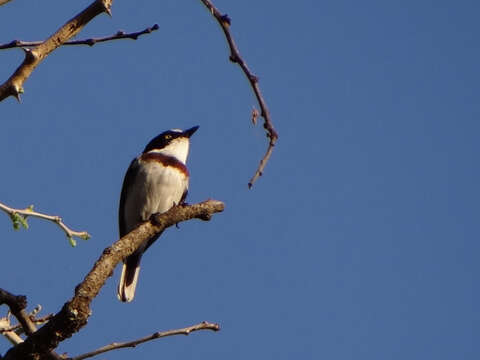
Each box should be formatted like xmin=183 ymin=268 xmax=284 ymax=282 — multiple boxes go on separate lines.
xmin=118 ymin=126 xmax=198 ymax=302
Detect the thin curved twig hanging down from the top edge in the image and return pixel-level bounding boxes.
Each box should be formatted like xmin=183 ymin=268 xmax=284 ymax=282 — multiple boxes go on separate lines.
xmin=200 ymin=0 xmax=278 ymax=188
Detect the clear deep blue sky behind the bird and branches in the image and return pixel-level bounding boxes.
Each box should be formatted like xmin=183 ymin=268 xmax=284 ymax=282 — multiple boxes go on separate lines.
xmin=0 ymin=0 xmax=480 ymax=360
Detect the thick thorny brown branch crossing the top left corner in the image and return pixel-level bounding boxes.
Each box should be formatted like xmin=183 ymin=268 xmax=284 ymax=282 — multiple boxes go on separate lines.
xmin=0 ymin=0 xmax=113 ymax=101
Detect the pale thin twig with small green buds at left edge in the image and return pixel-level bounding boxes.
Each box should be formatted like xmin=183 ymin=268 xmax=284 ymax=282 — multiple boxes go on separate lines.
xmin=0 ymin=203 xmax=90 ymax=246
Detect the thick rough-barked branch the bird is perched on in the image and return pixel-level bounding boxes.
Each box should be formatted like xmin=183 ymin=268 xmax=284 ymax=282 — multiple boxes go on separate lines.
xmin=3 ymin=200 xmax=224 ymax=360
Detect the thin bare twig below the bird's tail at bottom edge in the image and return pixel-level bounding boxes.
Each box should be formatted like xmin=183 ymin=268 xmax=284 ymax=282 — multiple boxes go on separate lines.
xmin=67 ymin=321 xmax=220 ymax=360
